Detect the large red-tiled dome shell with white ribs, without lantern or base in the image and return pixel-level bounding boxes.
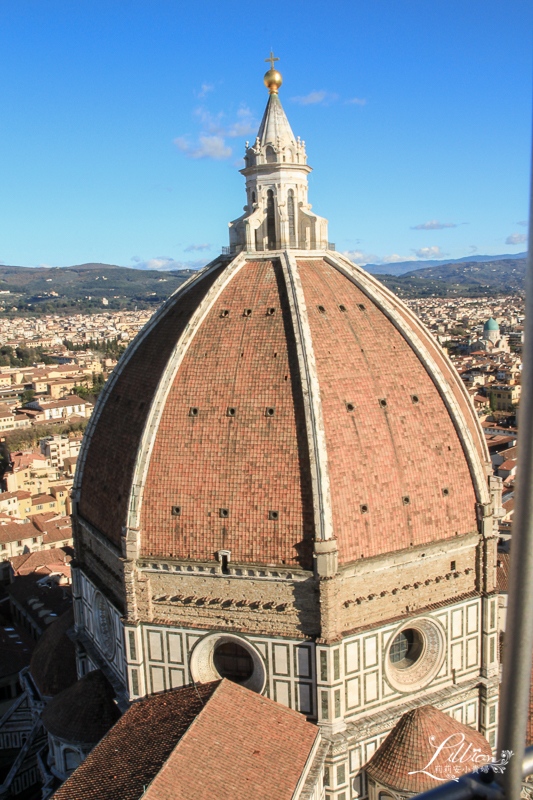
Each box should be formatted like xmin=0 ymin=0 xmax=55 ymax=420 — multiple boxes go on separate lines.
xmin=75 ymin=251 xmax=489 ymax=569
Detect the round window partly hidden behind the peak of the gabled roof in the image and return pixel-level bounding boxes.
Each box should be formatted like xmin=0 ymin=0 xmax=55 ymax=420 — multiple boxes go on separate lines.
xmin=190 ymin=633 xmax=266 ymax=694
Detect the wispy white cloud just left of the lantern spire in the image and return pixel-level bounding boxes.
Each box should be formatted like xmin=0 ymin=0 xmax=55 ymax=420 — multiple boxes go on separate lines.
xmin=174 ymin=106 xmax=259 ymax=161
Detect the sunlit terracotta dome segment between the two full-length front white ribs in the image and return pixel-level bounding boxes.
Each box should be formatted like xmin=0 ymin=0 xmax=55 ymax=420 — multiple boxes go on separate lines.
xmin=140 ymin=261 xmax=314 ymax=569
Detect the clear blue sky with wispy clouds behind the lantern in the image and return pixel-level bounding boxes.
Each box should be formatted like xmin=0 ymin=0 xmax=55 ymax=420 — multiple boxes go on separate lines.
xmin=0 ymin=0 xmax=533 ymax=267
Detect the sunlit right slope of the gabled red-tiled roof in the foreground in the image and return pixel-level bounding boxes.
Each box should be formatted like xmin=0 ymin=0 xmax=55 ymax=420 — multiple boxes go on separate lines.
xmin=141 ymin=681 xmax=319 ymax=800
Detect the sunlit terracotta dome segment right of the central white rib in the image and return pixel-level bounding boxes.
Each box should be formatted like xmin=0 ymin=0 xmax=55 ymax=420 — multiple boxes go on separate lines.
xmin=298 ymin=259 xmax=477 ymax=562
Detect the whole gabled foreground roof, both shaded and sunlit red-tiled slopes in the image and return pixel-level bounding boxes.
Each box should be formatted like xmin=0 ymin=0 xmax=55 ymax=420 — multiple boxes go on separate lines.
xmin=53 ymin=681 xmax=320 ymax=800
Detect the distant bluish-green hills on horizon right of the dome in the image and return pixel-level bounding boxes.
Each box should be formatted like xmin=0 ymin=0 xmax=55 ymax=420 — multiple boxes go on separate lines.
xmin=376 ymin=258 xmax=526 ymax=298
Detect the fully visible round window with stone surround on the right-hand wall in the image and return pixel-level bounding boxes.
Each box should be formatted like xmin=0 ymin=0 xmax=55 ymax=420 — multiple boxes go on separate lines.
xmin=385 ymin=618 xmax=445 ymax=692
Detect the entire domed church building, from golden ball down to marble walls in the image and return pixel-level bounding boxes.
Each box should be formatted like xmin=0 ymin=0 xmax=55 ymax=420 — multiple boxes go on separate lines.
xmin=67 ymin=59 xmax=502 ymax=800
